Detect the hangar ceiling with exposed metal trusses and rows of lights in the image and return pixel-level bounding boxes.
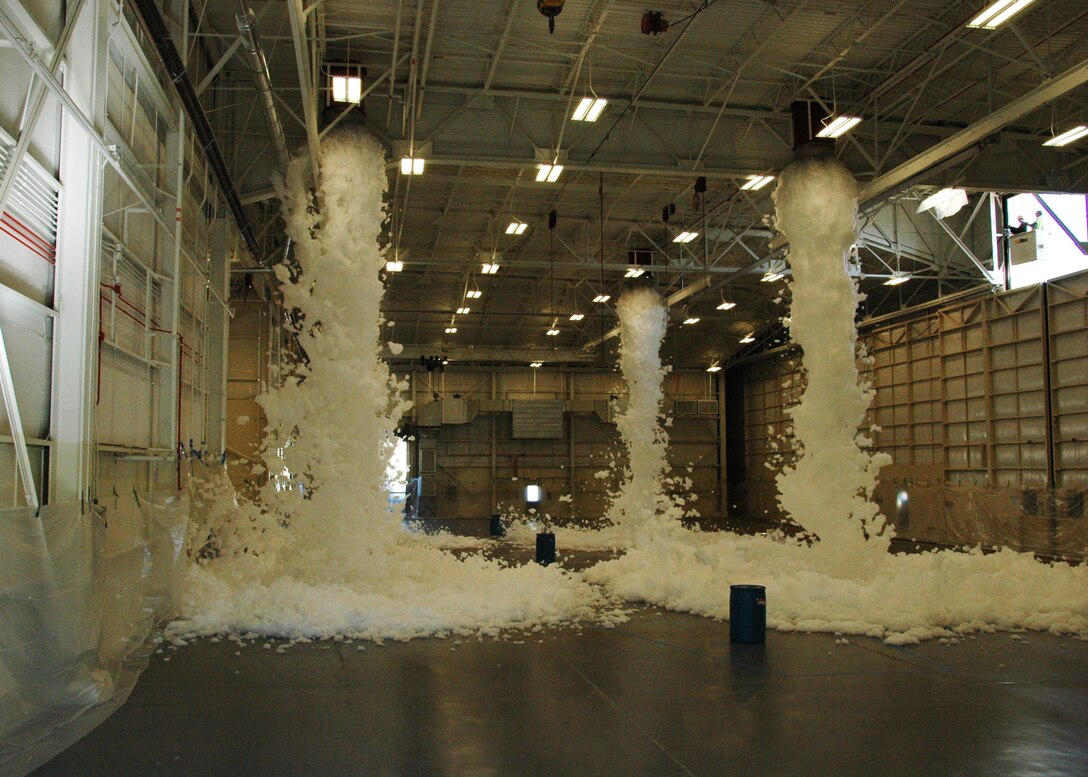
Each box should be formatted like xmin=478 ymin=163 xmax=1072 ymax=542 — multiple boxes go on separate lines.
xmin=161 ymin=0 xmax=1088 ymax=365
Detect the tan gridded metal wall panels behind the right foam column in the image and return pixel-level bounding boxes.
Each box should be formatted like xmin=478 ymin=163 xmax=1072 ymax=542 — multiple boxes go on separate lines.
xmin=731 ymin=273 xmax=1088 ymax=533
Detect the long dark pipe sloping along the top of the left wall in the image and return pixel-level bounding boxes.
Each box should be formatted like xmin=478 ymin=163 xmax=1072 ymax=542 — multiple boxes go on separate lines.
xmin=132 ymin=0 xmax=262 ymax=261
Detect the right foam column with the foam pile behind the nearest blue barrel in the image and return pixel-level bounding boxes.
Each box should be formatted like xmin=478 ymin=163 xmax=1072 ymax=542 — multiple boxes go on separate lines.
xmin=586 ymin=159 xmax=1088 ymax=644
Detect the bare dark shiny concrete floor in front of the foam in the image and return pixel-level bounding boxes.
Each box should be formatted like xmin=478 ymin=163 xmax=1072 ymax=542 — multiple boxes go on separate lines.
xmin=23 ymin=608 xmax=1088 ymax=777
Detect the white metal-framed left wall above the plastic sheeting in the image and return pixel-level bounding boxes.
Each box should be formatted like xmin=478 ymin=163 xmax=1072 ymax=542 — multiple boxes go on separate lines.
xmin=0 ymin=0 xmax=237 ymax=510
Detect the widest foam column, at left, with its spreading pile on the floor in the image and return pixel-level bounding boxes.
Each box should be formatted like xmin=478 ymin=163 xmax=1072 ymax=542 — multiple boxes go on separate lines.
xmin=169 ymin=135 xmax=623 ymax=639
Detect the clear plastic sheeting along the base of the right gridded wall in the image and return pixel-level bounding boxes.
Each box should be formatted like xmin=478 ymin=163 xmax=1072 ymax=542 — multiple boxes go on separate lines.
xmin=888 ymin=483 xmax=1088 ymax=560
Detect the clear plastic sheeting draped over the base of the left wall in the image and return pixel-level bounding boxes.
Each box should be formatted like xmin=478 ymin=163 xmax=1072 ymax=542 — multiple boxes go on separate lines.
xmin=0 ymin=494 xmax=188 ymax=769
